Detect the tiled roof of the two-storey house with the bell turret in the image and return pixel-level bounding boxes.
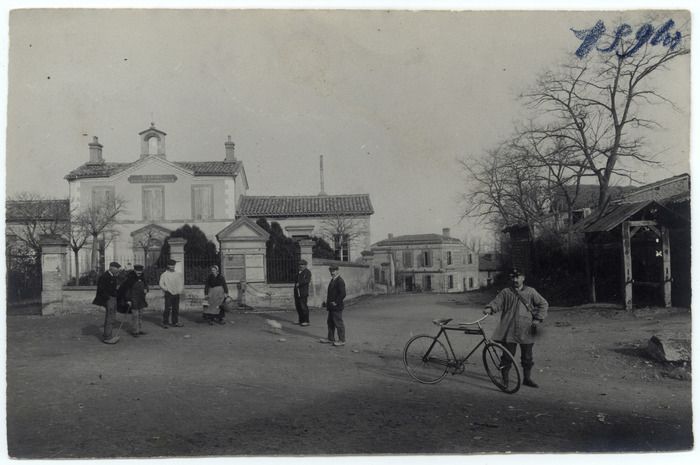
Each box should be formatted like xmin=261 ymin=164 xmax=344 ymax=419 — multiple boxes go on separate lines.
xmin=65 ymin=160 xmax=243 ymax=181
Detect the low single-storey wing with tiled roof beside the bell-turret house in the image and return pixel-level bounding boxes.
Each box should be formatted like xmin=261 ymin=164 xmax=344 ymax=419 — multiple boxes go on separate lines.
xmin=238 ymin=193 xmax=374 ymax=262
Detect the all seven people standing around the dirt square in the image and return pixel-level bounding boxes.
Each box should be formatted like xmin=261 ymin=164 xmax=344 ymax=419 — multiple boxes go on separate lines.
xmin=93 ymin=254 xmax=549 ymax=388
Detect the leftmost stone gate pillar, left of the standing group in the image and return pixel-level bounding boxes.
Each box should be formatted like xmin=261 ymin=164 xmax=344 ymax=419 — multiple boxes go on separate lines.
xmin=39 ymin=236 xmax=69 ymax=315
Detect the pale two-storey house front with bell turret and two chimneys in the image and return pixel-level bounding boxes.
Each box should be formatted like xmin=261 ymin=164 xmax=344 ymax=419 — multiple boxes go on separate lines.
xmin=65 ymin=123 xmax=248 ymax=269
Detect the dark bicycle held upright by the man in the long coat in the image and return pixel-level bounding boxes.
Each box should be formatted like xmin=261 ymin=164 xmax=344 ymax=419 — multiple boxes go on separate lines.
xmin=403 ymin=315 xmax=521 ymax=394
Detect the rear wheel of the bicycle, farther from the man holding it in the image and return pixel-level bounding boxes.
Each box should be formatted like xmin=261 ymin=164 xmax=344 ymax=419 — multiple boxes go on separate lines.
xmin=403 ymin=335 xmax=449 ymax=384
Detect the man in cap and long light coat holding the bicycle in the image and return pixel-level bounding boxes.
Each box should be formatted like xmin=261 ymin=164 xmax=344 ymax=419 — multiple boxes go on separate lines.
xmin=484 ymin=268 xmax=549 ymax=388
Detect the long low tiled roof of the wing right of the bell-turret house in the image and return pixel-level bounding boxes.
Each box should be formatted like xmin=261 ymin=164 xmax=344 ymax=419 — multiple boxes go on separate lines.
xmin=238 ymin=194 xmax=374 ymax=218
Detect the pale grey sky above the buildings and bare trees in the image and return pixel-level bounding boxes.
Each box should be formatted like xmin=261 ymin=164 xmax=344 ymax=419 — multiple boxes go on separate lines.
xmin=6 ymin=9 xmax=690 ymax=246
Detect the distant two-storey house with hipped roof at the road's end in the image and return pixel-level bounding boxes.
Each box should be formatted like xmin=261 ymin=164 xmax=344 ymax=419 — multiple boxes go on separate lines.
xmin=370 ymin=228 xmax=479 ymax=292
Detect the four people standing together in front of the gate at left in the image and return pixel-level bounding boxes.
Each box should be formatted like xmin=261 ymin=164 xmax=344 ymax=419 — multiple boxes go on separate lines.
xmin=92 ymin=259 xmax=229 ymax=344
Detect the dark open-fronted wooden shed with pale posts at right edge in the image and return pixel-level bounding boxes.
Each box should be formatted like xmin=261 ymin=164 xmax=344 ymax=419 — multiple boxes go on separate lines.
xmin=577 ymin=200 xmax=690 ymax=310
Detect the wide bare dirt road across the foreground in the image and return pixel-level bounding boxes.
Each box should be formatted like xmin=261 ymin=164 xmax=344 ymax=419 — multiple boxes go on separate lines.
xmin=7 ymin=293 xmax=693 ymax=458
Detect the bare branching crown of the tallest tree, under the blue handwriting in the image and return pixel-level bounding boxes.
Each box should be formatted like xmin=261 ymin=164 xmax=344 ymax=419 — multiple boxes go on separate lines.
xmin=523 ymin=17 xmax=689 ymax=212
